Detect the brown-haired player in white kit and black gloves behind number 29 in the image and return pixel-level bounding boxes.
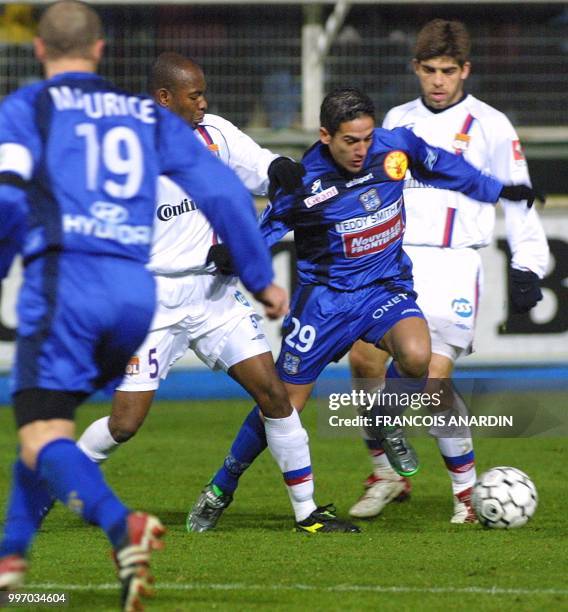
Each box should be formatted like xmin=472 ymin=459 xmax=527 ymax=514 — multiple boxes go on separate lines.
xmin=350 ymin=19 xmax=549 ymax=523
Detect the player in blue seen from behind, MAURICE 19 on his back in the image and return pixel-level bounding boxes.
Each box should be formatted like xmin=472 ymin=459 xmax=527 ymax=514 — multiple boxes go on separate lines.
xmin=0 ymin=0 xmax=287 ymax=610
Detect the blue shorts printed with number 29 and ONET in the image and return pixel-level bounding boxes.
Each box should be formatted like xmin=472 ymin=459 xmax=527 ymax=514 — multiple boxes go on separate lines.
xmin=276 ymin=279 xmax=424 ymax=385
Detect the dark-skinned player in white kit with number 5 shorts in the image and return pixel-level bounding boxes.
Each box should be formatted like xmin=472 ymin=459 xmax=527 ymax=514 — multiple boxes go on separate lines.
xmin=78 ymin=53 xmax=358 ymax=532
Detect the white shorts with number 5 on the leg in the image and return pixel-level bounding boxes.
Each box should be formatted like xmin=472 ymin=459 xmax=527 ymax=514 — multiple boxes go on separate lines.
xmin=118 ymin=275 xmax=270 ymax=391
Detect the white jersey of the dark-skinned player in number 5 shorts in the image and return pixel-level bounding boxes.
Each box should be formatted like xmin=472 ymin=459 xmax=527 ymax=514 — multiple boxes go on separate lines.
xmin=148 ymin=114 xmax=278 ymax=275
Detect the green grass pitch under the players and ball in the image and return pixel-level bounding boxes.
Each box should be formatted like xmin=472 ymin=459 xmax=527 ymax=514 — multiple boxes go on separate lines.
xmin=0 ymin=401 xmax=568 ymax=612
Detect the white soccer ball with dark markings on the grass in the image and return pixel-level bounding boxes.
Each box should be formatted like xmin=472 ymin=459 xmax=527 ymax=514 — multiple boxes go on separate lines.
xmin=471 ymin=467 xmax=538 ymax=529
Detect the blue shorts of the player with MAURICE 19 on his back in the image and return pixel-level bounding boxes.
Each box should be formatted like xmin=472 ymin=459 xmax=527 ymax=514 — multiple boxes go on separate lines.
xmin=12 ymin=253 xmax=155 ymax=394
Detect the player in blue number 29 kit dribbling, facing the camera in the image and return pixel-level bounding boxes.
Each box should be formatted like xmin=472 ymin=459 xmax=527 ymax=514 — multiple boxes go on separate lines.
xmin=189 ymin=88 xmax=534 ymax=532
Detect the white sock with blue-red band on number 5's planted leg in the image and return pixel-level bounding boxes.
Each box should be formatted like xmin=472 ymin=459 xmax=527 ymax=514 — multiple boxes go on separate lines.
xmin=264 ymin=410 xmax=316 ymax=522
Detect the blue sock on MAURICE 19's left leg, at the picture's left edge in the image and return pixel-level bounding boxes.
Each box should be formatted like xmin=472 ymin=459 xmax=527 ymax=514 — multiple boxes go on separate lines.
xmin=0 ymin=459 xmax=52 ymax=557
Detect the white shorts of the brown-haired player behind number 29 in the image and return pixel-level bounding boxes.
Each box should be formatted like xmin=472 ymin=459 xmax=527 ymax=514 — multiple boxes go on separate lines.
xmin=404 ymin=246 xmax=483 ymax=361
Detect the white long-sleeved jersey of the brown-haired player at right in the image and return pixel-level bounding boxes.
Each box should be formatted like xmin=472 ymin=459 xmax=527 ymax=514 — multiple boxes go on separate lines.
xmin=383 ymin=95 xmax=548 ymax=278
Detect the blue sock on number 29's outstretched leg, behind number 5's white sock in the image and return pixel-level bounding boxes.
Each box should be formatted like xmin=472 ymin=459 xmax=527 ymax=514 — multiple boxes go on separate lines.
xmin=212 ymin=406 xmax=267 ymax=494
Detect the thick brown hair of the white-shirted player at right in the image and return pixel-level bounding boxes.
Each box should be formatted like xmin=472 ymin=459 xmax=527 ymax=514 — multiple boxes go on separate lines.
xmin=414 ymin=19 xmax=471 ymax=66
